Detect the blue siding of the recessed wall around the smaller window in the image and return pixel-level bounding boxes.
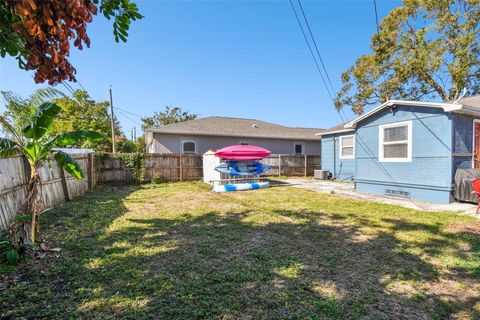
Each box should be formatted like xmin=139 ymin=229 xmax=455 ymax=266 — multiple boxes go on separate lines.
xmin=322 ymin=132 xmax=355 ymax=180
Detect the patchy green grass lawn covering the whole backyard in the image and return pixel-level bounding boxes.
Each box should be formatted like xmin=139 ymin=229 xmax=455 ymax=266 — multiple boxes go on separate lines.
xmin=0 ymin=183 xmax=480 ymax=319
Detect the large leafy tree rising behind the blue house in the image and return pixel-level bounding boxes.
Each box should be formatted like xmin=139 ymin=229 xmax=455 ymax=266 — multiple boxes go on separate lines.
xmin=336 ymin=0 xmax=480 ymax=114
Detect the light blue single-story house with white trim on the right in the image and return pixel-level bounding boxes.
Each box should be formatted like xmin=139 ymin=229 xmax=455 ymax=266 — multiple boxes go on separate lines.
xmin=318 ymin=96 xmax=480 ymax=203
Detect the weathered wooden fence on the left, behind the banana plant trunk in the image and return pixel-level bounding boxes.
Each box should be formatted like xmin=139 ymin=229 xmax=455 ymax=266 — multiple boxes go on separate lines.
xmin=0 ymin=154 xmax=97 ymax=230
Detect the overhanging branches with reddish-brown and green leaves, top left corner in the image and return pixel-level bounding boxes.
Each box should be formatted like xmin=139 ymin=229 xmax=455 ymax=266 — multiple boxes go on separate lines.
xmin=0 ymin=0 xmax=143 ymax=85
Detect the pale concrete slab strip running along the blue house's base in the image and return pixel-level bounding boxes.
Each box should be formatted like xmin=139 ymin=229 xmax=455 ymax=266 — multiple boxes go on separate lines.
xmin=284 ymin=179 xmax=480 ymax=219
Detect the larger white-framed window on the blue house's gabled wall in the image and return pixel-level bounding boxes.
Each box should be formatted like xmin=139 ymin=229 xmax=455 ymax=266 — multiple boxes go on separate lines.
xmin=378 ymin=121 xmax=412 ymax=162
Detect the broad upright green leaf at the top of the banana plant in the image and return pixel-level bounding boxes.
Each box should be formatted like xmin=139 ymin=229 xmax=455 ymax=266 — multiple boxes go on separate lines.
xmin=23 ymin=102 xmax=62 ymax=139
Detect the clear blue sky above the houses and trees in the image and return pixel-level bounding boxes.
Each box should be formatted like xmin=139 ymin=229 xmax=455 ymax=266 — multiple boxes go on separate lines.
xmin=0 ymin=0 xmax=400 ymax=136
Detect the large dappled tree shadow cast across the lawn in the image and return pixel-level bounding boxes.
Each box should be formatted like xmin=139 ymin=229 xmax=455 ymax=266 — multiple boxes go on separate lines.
xmin=2 ymin=188 xmax=480 ymax=319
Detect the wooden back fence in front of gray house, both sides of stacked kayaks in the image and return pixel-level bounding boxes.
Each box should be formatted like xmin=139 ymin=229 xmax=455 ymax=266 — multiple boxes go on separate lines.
xmin=96 ymin=153 xmax=320 ymax=183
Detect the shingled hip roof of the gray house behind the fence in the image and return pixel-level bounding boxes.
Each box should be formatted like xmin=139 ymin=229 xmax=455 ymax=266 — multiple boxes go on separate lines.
xmin=145 ymin=116 xmax=322 ymax=140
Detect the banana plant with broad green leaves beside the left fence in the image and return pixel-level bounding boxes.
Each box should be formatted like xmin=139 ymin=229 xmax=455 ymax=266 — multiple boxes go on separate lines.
xmin=0 ymin=102 xmax=106 ymax=244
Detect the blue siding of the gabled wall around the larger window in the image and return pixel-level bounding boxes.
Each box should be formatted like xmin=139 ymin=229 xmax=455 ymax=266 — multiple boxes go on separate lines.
xmin=355 ymin=106 xmax=452 ymax=203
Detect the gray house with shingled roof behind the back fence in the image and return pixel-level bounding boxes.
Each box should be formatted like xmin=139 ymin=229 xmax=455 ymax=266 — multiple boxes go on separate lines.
xmin=145 ymin=116 xmax=322 ymax=155
